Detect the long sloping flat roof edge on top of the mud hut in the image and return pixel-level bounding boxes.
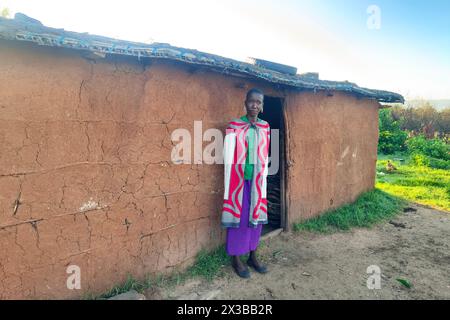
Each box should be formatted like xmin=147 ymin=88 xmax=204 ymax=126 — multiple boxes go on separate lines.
xmin=0 ymin=14 xmax=404 ymax=103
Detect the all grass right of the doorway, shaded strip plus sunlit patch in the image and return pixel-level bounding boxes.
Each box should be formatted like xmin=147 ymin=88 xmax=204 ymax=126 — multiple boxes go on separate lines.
xmin=294 ymin=154 xmax=450 ymax=233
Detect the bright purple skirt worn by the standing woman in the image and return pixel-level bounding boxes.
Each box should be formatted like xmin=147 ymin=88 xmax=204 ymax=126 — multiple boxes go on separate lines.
xmin=225 ymin=180 xmax=262 ymax=256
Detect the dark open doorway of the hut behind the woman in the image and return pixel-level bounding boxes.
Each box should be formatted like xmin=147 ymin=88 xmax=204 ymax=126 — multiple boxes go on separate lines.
xmin=259 ymin=96 xmax=286 ymax=234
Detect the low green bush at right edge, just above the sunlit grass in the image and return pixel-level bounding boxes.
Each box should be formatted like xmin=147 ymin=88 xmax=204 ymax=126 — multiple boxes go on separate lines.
xmin=406 ymin=135 xmax=450 ymax=160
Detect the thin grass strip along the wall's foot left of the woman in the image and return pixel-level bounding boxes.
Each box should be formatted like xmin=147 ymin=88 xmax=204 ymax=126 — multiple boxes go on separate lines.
xmin=83 ymin=245 xmax=230 ymax=300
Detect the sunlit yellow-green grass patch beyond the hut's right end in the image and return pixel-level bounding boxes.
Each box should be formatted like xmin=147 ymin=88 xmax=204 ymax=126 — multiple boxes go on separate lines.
xmin=376 ymin=155 xmax=450 ymax=211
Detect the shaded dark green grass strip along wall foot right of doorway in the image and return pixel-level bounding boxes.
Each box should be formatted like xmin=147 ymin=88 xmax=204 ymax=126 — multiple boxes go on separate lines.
xmin=293 ymin=189 xmax=405 ymax=233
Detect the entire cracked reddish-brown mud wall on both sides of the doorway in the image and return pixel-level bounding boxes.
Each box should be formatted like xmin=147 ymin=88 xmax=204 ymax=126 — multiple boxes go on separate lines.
xmin=0 ymin=41 xmax=378 ymax=299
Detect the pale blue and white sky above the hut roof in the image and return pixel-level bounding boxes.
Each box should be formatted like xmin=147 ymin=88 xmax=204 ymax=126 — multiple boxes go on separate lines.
xmin=0 ymin=0 xmax=450 ymax=99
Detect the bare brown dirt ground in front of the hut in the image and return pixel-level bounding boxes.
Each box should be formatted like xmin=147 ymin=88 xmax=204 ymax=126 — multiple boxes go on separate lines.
xmin=152 ymin=204 xmax=450 ymax=300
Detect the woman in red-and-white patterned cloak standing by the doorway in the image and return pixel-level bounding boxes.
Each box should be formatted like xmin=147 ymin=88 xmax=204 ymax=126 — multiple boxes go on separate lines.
xmin=221 ymin=89 xmax=270 ymax=278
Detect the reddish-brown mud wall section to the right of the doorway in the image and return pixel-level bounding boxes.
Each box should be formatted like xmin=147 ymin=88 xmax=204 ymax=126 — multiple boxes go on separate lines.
xmin=286 ymin=92 xmax=379 ymax=223
